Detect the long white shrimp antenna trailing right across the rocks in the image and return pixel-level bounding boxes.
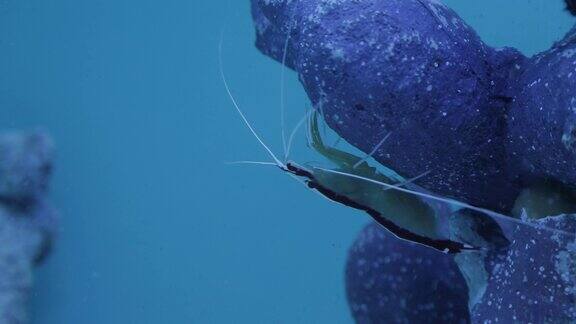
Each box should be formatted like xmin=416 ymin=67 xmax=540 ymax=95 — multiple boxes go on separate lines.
xmin=312 ymin=167 xmax=576 ymax=237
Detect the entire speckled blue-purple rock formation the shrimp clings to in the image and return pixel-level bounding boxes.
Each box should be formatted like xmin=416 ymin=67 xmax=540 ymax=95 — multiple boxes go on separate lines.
xmin=251 ymin=0 xmax=576 ymax=323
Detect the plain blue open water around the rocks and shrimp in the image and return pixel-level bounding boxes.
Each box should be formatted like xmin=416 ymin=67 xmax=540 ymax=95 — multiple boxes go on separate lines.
xmin=0 ymin=0 xmax=573 ymax=324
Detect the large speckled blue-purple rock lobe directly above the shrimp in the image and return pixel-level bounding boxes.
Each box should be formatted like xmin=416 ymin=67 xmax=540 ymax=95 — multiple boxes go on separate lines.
xmin=252 ymin=0 xmax=526 ymax=210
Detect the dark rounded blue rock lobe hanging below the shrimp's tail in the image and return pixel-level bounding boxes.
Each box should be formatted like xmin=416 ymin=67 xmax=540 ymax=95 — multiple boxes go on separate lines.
xmin=346 ymin=224 xmax=470 ymax=323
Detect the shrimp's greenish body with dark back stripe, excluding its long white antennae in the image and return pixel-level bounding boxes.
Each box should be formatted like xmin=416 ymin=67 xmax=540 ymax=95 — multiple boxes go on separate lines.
xmin=281 ymin=113 xmax=473 ymax=253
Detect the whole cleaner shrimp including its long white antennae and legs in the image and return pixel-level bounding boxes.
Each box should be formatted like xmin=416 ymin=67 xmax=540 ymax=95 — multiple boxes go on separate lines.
xmin=219 ymin=28 xmax=576 ymax=254
